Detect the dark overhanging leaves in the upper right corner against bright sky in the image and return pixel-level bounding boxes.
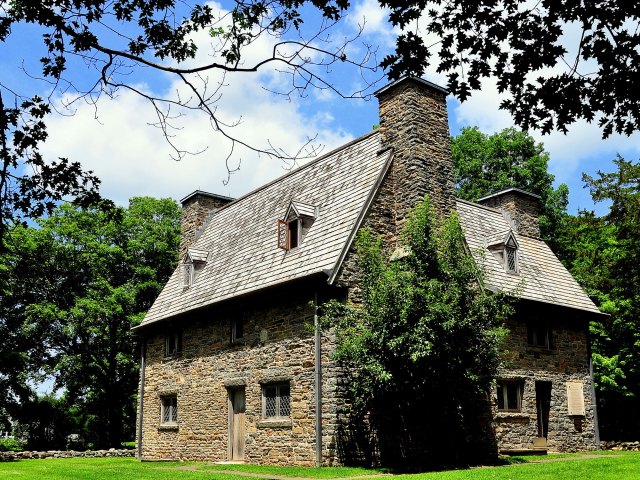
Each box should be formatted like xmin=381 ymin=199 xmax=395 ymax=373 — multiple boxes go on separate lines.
xmin=380 ymin=0 xmax=640 ymax=137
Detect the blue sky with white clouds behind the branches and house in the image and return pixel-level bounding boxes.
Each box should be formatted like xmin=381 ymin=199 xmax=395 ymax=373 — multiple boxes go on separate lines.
xmin=0 ymin=0 xmax=640 ymax=213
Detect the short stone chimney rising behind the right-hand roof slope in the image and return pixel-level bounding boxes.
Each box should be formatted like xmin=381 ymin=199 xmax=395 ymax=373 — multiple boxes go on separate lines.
xmin=478 ymin=188 xmax=540 ymax=238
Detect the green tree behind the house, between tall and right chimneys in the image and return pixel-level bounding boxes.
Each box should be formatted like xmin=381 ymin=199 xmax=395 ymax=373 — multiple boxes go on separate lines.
xmin=451 ymin=127 xmax=569 ymax=249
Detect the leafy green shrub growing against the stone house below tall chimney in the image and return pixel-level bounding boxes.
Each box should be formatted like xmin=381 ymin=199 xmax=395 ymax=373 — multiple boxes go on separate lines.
xmin=323 ymin=201 xmax=512 ymax=468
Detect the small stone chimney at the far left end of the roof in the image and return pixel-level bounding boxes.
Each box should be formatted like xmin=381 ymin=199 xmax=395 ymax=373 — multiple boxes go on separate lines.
xmin=180 ymin=190 xmax=233 ymax=261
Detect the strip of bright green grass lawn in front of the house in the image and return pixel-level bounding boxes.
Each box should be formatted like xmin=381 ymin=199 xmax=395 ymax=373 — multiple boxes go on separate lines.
xmin=0 ymin=452 xmax=640 ymax=480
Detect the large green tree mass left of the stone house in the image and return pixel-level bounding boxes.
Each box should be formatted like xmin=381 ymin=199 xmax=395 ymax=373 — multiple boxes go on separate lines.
xmin=0 ymin=197 xmax=180 ymax=447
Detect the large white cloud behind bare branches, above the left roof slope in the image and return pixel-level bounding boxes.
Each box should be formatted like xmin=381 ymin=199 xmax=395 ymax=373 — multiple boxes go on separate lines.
xmin=43 ymin=3 xmax=351 ymax=204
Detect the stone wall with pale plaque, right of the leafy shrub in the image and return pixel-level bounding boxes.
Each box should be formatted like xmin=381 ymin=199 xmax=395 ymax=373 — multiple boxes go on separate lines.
xmin=493 ymin=315 xmax=597 ymax=452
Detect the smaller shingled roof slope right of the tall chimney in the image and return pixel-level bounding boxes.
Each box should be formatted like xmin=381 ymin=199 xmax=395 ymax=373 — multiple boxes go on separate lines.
xmin=456 ymin=200 xmax=600 ymax=313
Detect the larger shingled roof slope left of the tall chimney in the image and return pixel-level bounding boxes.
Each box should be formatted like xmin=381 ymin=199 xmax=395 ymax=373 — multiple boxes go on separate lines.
xmin=140 ymin=132 xmax=391 ymax=327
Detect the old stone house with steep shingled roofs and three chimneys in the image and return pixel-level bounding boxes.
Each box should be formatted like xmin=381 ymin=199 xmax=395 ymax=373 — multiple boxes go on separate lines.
xmin=135 ymin=78 xmax=600 ymax=465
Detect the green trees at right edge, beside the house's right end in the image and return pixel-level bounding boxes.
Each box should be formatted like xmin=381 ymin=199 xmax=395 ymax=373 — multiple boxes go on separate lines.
xmin=561 ymin=157 xmax=640 ymax=439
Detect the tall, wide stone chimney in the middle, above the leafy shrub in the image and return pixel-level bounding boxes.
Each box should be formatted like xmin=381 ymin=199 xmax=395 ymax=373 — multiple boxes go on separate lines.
xmin=375 ymin=77 xmax=455 ymax=225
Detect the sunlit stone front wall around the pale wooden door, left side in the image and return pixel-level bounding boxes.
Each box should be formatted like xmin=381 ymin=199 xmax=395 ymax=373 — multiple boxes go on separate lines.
xmin=142 ymin=282 xmax=336 ymax=465
